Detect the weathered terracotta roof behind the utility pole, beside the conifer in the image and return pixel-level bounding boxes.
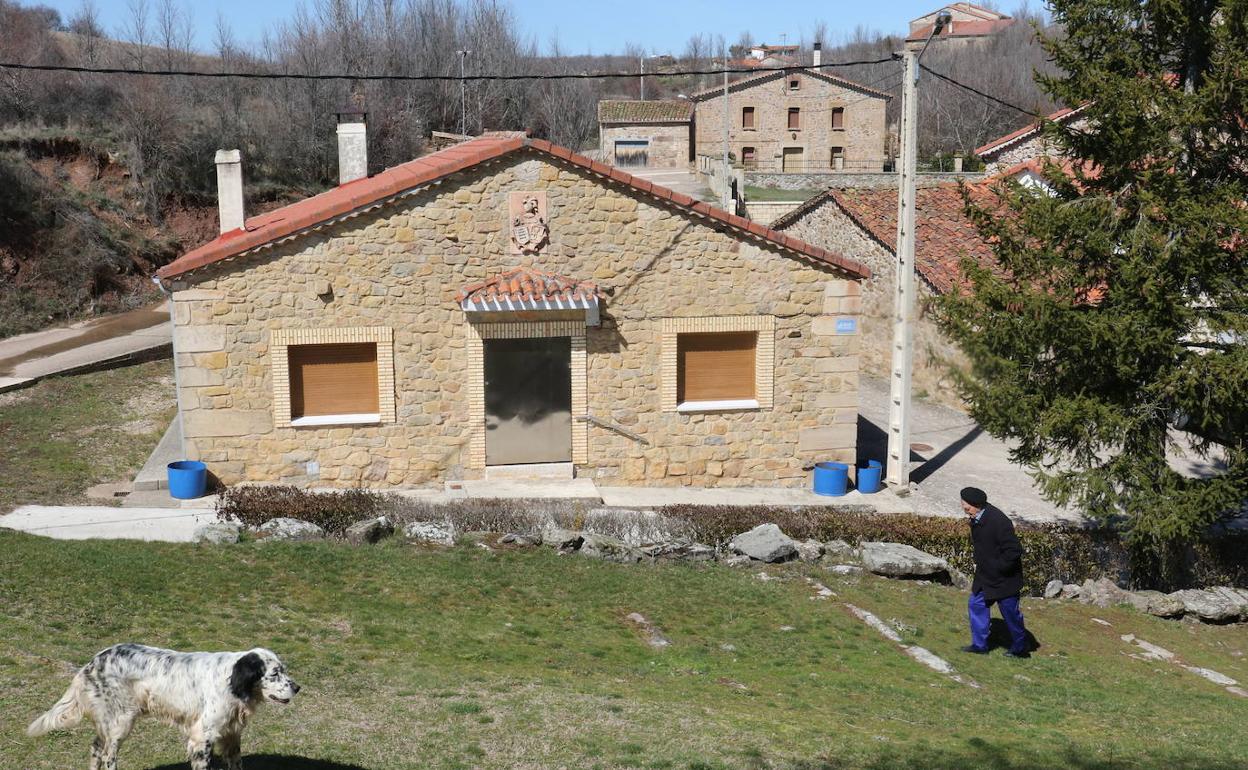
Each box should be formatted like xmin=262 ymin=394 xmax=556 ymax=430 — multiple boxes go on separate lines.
xmin=771 ymin=183 xmax=996 ymax=293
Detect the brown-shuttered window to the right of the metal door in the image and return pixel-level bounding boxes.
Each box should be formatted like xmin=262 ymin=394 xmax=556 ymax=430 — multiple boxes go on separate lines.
xmin=676 ymin=332 xmax=759 ymax=403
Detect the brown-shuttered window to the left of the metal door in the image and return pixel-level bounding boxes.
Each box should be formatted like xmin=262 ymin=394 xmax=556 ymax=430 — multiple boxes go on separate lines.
xmin=287 ymin=342 xmax=379 ymax=421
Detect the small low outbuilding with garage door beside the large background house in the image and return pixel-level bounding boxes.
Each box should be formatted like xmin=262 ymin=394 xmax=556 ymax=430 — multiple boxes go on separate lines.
xmin=598 ymin=100 xmax=693 ymax=168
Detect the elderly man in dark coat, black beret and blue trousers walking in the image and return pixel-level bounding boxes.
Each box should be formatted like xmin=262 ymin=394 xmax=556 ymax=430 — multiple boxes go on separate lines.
xmin=961 ymin=487 xmax=1031 ymax=658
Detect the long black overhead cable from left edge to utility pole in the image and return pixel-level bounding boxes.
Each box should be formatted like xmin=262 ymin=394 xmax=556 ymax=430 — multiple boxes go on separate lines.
xmin=0 ymin=56 xmax=892 ymax=82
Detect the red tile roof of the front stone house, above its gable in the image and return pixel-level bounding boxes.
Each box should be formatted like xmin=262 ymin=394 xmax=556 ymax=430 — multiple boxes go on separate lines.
xmin=156 ymin=137 xmax=871 ymax=278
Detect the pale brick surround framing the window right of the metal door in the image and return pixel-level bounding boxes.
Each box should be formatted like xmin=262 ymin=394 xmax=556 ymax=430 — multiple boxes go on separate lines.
xmin=659 ymin=316 xmax=776 ymax=412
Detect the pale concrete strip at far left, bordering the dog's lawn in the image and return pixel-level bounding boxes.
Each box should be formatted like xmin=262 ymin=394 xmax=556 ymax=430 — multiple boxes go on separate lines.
xmin=0 ymin=500 xmax=217 ymax=543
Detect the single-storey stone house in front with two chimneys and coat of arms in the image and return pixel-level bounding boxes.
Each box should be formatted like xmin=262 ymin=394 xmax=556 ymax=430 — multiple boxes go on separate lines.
xmin=157 ymin=131 xmax=870 ymax=487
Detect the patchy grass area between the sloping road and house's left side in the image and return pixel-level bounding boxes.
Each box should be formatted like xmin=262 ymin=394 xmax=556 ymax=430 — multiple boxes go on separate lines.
xmin=0 ymin=361 xmax=175 ymax=513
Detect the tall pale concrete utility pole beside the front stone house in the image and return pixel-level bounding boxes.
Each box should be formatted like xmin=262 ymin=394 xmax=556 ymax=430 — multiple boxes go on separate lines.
xmin=886 ymin=50 xmax=919 ymax=490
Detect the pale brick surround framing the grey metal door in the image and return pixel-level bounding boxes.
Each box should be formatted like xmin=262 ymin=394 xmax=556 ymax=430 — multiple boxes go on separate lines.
xmin=464 ymin=321 xmax=589 ymax=470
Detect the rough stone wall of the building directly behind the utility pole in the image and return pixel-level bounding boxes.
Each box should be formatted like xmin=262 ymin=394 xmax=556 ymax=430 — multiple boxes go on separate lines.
xmin=782 ymin=201 xmax=967 ymax=407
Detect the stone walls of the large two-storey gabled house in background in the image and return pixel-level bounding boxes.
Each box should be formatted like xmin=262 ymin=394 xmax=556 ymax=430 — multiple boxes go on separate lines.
xmin=694 ymin=72 xmax=887 ymax=171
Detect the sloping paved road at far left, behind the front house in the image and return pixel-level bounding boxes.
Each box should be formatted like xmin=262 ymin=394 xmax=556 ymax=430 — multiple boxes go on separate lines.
xmin=0 ymin=303 xmax=172 ymax=393
